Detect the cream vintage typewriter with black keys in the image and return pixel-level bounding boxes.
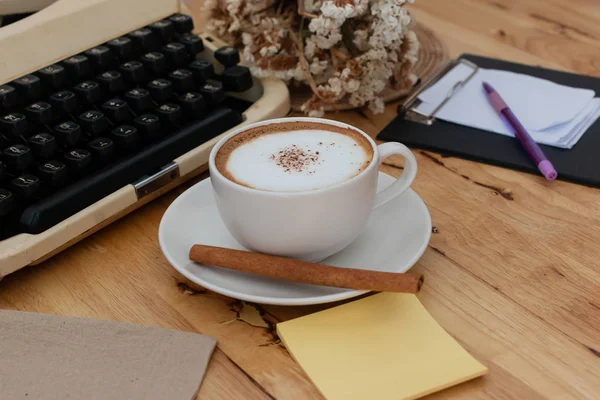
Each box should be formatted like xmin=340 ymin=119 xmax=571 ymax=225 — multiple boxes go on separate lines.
xmin=0 ymin=0 xmax=290 ymax=279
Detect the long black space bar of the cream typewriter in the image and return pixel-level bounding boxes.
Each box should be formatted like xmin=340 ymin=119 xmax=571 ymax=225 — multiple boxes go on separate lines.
xmin=20 ymin=108 xmax=243 ymax=234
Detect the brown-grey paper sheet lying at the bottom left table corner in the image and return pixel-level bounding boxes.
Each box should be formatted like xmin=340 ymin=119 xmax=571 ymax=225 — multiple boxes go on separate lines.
xmin=0 ymin=310 xmax=216 ymax=400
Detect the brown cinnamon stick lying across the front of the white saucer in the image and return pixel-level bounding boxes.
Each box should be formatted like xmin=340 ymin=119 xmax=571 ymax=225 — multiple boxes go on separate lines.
xmin=190 ymin=244 xmax=423 ymax=294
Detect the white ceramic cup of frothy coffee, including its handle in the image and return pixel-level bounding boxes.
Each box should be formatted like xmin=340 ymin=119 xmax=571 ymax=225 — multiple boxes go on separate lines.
xmin=209 ymin=118 xmax=417 ymax=262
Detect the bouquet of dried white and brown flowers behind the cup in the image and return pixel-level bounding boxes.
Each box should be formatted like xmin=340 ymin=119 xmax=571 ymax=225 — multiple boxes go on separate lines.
xmin=205 ymin=0 xmax=419 ymax=116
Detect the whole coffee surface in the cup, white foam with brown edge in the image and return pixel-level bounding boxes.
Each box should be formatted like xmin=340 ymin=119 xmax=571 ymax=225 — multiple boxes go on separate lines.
xmin=215 ymin=121 xmax=373 ymax=192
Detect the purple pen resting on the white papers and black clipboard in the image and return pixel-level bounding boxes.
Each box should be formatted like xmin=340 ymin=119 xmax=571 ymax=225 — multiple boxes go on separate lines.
xmin=483 ymin=82 xmax=558 ymax=181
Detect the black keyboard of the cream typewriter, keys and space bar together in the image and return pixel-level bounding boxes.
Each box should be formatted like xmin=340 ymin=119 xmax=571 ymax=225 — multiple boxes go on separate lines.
xmin=0 ymin=14 xmax=253 ymax=240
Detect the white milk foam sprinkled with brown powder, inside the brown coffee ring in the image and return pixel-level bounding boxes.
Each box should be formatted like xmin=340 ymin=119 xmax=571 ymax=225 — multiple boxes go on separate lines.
xmin=226 ymin=129 xmax=371 ymax=192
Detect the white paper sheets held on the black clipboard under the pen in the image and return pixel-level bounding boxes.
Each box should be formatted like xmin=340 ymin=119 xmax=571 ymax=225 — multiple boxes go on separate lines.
xmin=417 ymin=64 xmax=600 ymax=149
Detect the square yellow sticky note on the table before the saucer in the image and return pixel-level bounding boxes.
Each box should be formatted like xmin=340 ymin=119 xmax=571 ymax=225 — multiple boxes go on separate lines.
xmin=277 ymin=293 xmax=487 ymax=400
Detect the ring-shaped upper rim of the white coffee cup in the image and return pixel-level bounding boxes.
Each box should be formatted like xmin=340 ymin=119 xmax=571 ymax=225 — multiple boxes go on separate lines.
xmin=208 ymin=117 xmax=379 ymax=197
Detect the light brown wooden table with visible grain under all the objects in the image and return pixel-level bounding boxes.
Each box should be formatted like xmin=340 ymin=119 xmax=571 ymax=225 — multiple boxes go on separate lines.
xmin=0 ymin=0 xmax=600 ymax=400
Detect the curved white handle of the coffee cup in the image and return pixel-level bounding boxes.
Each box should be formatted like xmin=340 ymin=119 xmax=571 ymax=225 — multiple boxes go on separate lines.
xmin=373 ymin=142 xmax=417 ymax=209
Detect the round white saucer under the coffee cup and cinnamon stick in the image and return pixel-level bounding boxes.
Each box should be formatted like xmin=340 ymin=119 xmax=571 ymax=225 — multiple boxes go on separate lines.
xmin=158 ymin=173 xmax=431 ymax=306
